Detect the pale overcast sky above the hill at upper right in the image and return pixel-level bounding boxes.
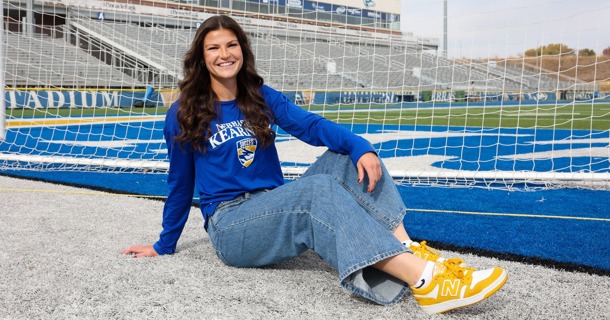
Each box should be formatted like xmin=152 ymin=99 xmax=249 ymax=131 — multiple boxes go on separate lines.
xmin=400 ymin=0 xmax=610 ymax=58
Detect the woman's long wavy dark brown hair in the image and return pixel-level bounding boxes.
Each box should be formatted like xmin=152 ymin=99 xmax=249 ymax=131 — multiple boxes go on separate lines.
xmin=176 ymin=15 xmax=274 ymax=152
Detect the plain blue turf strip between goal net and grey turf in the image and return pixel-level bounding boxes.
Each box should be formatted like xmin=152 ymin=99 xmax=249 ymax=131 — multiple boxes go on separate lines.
xmin=0 ymin=170 xmax=610 ymax=275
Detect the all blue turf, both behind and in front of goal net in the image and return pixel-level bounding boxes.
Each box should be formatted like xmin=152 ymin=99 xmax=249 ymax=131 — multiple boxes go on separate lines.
xmin=0 ymin=115 xmax=610 ymax=271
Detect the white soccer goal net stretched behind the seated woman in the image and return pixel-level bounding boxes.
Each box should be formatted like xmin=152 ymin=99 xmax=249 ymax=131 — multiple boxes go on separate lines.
xmin=0 ymin=0 xmax=610 ymax=189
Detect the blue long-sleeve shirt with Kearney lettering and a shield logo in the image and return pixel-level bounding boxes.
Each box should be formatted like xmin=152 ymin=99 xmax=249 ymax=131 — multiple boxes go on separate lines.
xmin=154 ymin=86 xmax=375 ymax=254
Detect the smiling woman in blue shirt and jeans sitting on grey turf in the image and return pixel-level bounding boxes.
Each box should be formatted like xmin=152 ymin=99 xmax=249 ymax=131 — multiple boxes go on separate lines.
xmin=123 ymin=15 xmax=507 ymax=313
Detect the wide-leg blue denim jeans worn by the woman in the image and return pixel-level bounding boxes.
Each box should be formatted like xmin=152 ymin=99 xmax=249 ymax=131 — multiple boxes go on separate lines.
xmin=208 ymin=151 xmax=408 ymax=304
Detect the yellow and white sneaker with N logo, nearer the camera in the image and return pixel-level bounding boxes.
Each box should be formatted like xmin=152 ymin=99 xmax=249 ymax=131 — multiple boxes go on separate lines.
xmin=411 ymin=258 xmax=508 ymax=314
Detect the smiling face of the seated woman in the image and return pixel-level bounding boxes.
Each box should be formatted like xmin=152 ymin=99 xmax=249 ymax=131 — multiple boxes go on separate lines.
xmin=203 ymin=29 xmax=244 ymax=87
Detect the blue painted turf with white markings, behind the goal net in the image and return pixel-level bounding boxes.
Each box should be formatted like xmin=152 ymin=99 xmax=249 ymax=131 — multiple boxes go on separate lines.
xmin=0 ymin=121 xmax=610 ymax=172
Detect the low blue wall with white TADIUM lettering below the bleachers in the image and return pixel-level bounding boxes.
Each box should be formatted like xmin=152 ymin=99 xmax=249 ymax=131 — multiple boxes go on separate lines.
xmin=4 ymin=87 xmax=610 ymax=109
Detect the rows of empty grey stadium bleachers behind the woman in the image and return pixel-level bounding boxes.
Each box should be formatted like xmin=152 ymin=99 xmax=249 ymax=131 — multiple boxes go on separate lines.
xmin=5 ymin=8 xmax=580 ymax=92
